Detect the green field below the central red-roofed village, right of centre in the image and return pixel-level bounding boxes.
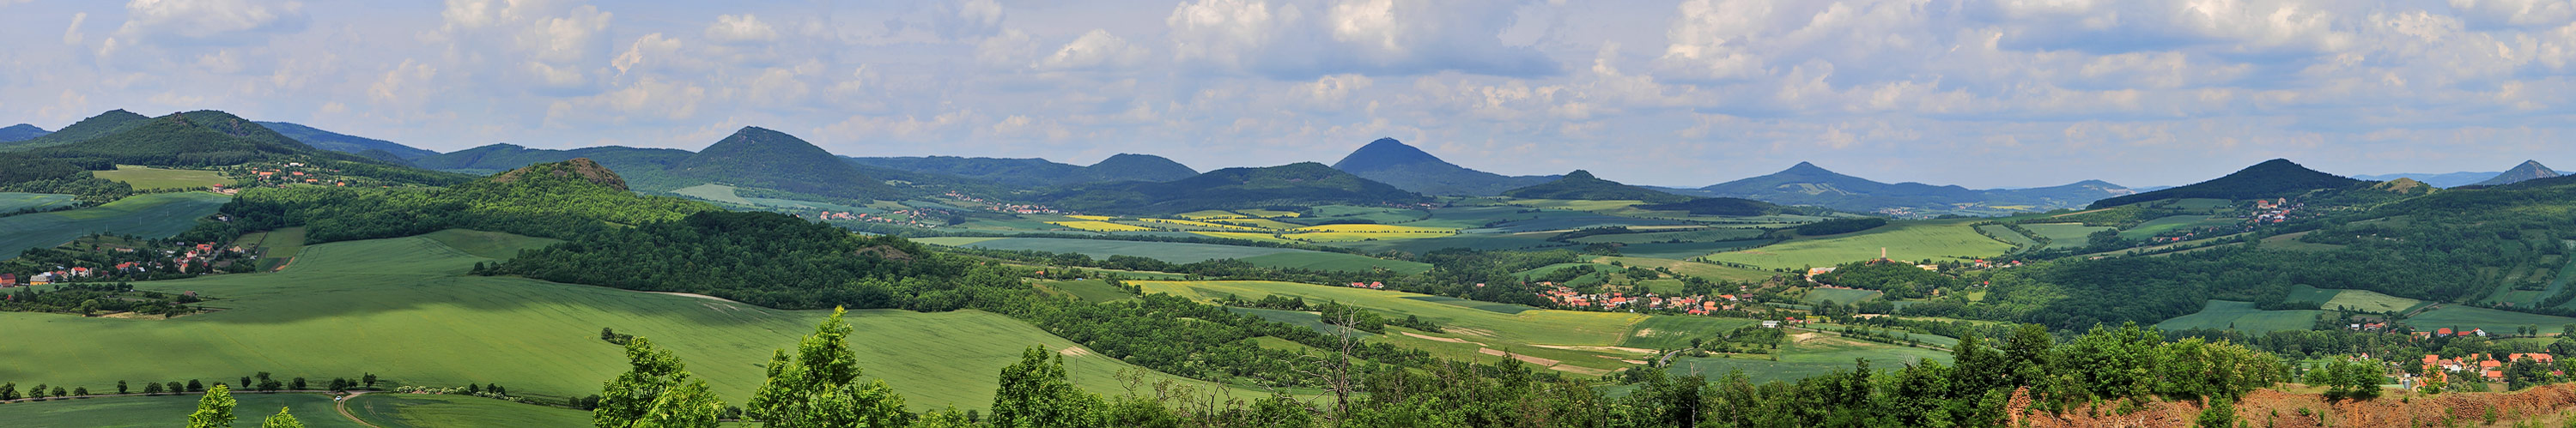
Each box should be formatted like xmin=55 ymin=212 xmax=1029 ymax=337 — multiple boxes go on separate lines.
xmin=1672 ymin=333 xmax=1950 ymax=384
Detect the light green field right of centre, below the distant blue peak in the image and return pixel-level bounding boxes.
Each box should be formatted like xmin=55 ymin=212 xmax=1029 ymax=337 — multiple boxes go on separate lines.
xmin=1708 ymin=220 xmax=2012 ymax=268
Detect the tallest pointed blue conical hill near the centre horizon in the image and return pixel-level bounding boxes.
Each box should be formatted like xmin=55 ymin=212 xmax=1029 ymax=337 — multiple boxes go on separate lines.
xmin=1332 ymin=139 xmax=1551 ymax=196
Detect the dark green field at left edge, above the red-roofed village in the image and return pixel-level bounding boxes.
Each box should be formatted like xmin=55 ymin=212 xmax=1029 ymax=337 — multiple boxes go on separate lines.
xmin=0 ymin=190 xmax=232 ymax=258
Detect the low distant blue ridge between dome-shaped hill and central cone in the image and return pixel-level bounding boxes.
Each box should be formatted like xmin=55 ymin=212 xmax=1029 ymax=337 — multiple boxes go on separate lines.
xmin=848 ymin=152 xmax=1198 ymax=188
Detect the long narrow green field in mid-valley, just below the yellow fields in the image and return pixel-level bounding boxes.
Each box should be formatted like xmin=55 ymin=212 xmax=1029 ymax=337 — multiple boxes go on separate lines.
xmin=917 ymin=238 xmax=1432 ymax=274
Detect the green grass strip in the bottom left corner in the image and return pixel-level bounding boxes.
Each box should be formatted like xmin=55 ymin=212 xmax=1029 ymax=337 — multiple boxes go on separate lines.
xmin=0 ymin=391 xmax=368 ymax=428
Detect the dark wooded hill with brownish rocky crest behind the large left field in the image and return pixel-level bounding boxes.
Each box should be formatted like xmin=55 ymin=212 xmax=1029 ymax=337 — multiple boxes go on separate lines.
xmin=210 ymin=160 xmax=716 ymax=243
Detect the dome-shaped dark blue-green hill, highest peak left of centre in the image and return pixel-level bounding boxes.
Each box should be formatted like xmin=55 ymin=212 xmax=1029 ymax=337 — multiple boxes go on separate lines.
xmin=670 ymin=126 xmax=894 ymax=201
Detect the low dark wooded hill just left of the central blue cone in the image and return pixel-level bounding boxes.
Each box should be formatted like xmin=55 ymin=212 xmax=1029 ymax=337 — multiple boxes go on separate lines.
xmin=1038 ymin=162 xmax=1430 ymax=214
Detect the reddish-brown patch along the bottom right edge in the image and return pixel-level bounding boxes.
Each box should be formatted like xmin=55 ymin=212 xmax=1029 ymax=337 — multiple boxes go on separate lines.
xmin=2007 ymin=384 xmax=2576 ymax=428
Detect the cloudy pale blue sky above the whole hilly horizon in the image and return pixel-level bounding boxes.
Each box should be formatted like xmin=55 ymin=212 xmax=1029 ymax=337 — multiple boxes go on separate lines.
xmin=0 ymin=0 xmax=2576 ymax=188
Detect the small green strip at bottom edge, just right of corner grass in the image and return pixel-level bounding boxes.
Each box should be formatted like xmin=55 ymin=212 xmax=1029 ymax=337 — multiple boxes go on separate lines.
xmin=348 ymin=395 xmax=592 ymax=428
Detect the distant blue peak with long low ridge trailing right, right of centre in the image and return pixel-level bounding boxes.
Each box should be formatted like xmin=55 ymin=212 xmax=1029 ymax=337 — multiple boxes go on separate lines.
xmin=1687 ymin=162 xmax=2136 ymax=211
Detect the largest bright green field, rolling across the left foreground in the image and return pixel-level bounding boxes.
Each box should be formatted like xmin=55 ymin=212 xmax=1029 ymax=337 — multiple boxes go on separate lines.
xmin=0 ymin=238 xmax=1252 ymax=410
